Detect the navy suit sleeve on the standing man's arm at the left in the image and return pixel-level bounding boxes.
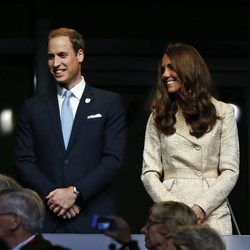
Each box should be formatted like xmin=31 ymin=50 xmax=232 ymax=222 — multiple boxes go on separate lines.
xmin=14 ymin=101 xmax=56 ymax=198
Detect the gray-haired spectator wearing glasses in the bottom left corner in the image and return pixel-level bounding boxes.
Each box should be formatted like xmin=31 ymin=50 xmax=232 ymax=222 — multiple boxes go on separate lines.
xmin=0 ymin=188 xmax=67 ymax=250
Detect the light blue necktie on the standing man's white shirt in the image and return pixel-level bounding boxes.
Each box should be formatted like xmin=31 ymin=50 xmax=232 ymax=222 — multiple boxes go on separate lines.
xmin=61 ymin=90 xmax=74 ymax=148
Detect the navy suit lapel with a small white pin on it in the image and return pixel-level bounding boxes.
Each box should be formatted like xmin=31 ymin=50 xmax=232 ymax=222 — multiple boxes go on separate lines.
xmin=68 ymin=84 xmax=94 ymax=150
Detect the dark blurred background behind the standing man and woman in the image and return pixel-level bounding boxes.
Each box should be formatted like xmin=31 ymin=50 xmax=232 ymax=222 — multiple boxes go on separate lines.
xmin=0 ymin=0 xmax=250 ymax=234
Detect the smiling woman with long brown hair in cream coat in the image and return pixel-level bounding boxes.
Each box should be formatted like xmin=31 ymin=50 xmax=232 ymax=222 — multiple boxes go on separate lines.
xmin=141 ymin=43 xmax=239 ymax=235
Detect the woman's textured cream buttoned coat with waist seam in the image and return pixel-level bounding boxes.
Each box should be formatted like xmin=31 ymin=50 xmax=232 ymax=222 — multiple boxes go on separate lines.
xmin=141 ymin=98 xmax=239 ymax=235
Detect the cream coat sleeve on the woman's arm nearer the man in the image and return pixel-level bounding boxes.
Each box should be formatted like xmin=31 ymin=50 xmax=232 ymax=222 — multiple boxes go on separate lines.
xmin=141 ymin=114 xmax=178 ymax=202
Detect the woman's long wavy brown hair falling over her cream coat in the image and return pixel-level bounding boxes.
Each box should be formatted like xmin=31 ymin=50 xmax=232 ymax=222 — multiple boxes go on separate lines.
xmin=150 ymin=43 xmax=219 ymax=138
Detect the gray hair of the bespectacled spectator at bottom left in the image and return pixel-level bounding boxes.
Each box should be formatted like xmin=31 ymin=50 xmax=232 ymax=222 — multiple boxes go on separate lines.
xmin=0 ymin=189 xmax=45 ymax=233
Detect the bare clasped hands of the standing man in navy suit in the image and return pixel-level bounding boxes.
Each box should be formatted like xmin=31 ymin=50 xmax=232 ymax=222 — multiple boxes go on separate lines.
xmin=46 ymin=186 xmax=81 ymax=219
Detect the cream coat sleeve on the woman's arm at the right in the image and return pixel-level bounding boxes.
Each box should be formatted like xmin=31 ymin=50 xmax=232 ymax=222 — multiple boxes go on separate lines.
xmin=195 ymin=104 xmax=239 ymax=214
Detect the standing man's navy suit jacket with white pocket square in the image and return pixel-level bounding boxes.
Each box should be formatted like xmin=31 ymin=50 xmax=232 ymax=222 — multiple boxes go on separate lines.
xmin=15 ymin=84 xmax=126 ymax=233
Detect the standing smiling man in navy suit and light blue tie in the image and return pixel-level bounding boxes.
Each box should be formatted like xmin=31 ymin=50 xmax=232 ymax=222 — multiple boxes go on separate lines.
xmin=15 ymin=28 xmax=126 ymax=233
